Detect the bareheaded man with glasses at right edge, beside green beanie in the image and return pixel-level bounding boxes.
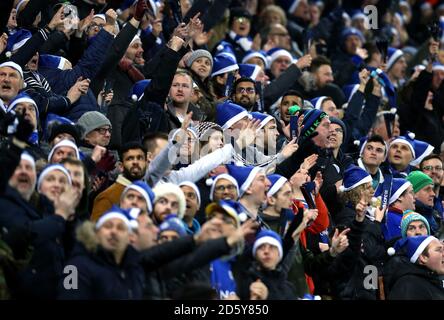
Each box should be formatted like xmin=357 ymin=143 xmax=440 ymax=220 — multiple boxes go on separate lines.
xmin=419 ymin=154 xmax=444 ymax=217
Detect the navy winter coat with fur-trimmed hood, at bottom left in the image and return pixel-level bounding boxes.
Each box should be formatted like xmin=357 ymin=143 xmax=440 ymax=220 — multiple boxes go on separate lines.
xmin=58 ymin=222 xmax=145 ymax=300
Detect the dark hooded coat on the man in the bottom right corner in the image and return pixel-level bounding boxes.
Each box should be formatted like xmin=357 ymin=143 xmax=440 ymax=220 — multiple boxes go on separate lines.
xmin=384 ymin=255 xmax=444 ymax=300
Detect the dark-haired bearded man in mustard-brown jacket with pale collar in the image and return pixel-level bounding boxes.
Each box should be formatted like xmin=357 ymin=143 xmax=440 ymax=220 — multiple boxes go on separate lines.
xmin=91 ymin=142 xmax=147 ymax=221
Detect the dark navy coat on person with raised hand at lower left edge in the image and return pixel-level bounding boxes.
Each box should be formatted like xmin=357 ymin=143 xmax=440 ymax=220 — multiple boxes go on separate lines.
xmin=0 ymin=187 xmax=65 ymax=299
